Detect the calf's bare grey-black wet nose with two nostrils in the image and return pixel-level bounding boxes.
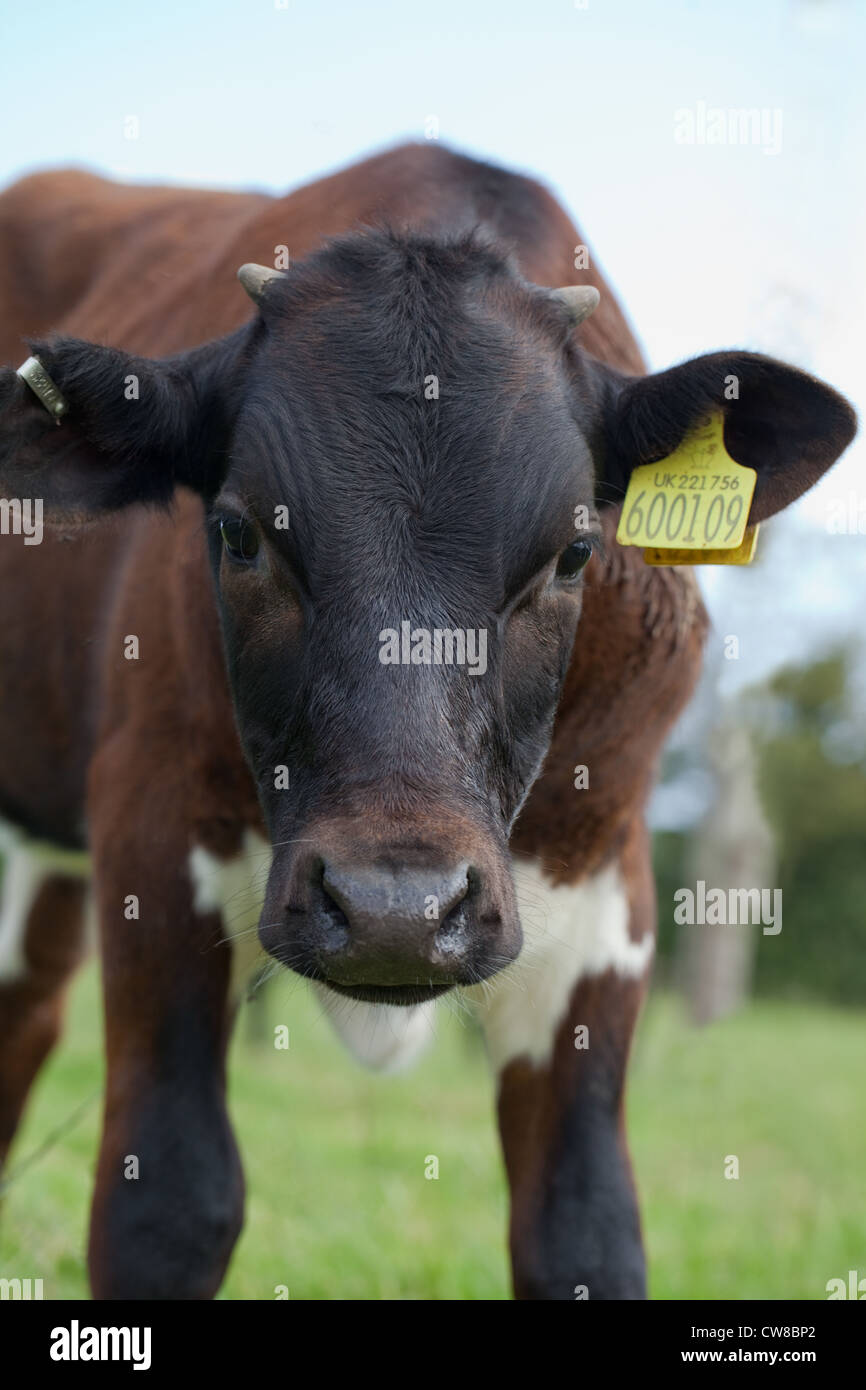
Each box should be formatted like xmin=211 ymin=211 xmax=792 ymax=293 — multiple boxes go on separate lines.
xmin=313 ymin=860 xmax=474 ymax=987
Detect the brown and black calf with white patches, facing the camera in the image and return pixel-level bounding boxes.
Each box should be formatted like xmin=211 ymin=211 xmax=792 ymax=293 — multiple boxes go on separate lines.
xmin=0 ymin=143 xmax=855 ymax=1300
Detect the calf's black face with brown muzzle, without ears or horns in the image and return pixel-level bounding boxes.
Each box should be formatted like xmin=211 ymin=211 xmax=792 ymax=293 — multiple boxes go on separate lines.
xmin=210 ymin=236 xmax=598 ymax=1002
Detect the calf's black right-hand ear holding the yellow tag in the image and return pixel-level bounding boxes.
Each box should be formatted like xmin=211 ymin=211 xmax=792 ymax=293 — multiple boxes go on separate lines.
xmin=589 ymin=352 xmax=856 ymax=524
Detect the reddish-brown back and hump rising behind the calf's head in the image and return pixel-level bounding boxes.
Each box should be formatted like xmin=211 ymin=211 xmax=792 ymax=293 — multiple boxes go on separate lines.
xmin=0 ymin=145 xmax=644 ymax=371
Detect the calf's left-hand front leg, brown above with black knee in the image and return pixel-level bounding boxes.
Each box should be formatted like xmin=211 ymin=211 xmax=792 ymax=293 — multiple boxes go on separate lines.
xmin=89 ymin=800 xmax=243 ymax=1298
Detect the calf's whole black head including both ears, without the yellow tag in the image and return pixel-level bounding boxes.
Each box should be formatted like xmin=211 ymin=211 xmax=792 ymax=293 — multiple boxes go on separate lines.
xmin=0 ymin=234 xmax=853 ymax=1004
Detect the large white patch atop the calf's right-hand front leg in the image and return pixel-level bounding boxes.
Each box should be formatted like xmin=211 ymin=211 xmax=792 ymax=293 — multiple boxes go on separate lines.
xmin=466 ymin=862 xmax=653 ymax=1072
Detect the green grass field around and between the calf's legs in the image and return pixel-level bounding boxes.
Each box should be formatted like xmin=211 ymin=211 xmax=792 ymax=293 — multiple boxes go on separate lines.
xmin=0 ymin=967 xmax=866 ymax=1300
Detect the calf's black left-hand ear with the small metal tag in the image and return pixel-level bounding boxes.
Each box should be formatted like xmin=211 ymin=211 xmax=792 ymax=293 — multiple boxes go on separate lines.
xmin=0 ymin=331 xmax=245 ymax=523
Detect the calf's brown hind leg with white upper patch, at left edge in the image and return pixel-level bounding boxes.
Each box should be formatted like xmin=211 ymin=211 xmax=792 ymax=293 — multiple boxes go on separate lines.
xmin=0 ymin=837 xmax=86 ymax=1163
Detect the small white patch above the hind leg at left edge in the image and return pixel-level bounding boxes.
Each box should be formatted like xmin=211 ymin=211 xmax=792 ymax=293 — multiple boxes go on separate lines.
xmin=0 ymin=821 xmax=90 ymax=981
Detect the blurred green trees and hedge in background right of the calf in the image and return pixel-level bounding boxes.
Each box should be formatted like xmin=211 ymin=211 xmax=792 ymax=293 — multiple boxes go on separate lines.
xmin=655 ymin=645 xmax=866 ymax=1012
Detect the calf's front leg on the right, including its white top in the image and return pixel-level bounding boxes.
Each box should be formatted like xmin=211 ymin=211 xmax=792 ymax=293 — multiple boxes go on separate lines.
xmin=469 ymin=865 xmax=653 ymax=1300
